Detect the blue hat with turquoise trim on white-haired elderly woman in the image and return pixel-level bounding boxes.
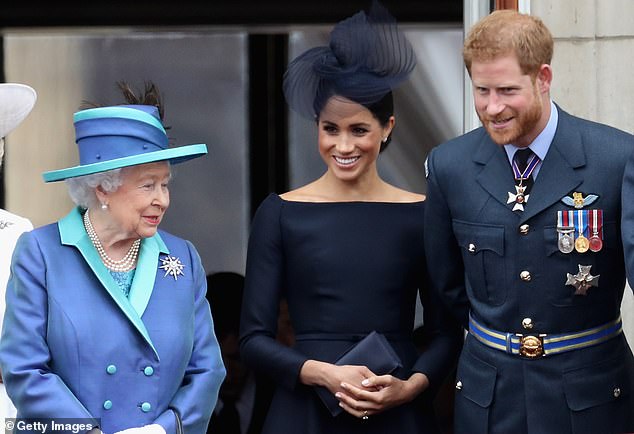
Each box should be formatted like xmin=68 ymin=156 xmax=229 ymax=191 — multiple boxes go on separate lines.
xmin=42 ymin=105 xmax=207 ymax=182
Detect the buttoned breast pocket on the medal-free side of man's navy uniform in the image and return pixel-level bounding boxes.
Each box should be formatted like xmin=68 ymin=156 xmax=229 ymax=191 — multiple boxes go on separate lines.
xmin=453 ymin=220 xmax=507 ymax=306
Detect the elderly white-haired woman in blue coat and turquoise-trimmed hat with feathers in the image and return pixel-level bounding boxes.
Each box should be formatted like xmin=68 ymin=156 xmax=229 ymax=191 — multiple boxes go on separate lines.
xmin=0 ymin=83 xmax=225 ymax=434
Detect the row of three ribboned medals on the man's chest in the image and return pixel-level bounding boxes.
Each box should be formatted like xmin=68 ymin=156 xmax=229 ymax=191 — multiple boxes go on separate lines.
xmin=557 ymin=209 xmax=603 ymax=253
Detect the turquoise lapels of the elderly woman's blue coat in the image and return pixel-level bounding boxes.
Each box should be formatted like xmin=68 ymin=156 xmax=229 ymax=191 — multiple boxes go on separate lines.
xmin=58 ymin=208 xmax=169 ymax=357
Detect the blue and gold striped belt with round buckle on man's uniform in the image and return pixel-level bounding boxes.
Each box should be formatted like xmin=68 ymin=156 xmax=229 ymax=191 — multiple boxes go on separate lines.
xmin=469 ymin=315 xmax=623 ymax=359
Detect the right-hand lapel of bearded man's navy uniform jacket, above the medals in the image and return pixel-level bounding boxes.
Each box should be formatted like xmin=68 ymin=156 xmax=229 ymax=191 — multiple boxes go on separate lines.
xmin=520 ymin=108 xmax=586 ymax=222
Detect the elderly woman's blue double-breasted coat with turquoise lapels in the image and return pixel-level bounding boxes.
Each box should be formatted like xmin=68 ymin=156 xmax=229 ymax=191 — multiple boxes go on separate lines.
xmin=0 ymin=210 xmax=225 ymax=434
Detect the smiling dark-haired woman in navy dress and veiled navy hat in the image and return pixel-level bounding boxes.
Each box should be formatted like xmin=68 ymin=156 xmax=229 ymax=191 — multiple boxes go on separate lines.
xmin=241 ymin=4 xmax=461 ymax=434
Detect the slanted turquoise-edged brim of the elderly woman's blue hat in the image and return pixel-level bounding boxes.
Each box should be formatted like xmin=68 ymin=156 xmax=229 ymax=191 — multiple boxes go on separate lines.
xmin=42 ymin=144 xmax=207 ymax=182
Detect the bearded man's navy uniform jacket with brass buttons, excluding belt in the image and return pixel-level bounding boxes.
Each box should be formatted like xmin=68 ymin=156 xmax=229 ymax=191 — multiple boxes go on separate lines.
xmin=425 ymin=105 xmax=634 ymax=434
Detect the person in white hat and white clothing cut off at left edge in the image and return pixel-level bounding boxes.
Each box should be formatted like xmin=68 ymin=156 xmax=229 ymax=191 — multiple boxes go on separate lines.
xmin=0 ymin=83 xmax=37 ymax=426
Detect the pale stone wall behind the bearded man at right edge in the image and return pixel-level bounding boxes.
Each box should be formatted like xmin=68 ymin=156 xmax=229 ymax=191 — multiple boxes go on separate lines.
xmin=530 ymin=0 xmax=634 ymax=346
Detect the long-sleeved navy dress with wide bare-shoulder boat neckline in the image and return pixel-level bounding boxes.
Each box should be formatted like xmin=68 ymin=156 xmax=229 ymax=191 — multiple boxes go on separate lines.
xmin=241 ymin=194 xmax=461 ymax=434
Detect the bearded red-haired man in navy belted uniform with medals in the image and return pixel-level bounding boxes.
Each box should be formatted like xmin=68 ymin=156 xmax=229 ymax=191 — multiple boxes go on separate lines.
xmin=425 ymin=10 xmax=634 ymax=434
